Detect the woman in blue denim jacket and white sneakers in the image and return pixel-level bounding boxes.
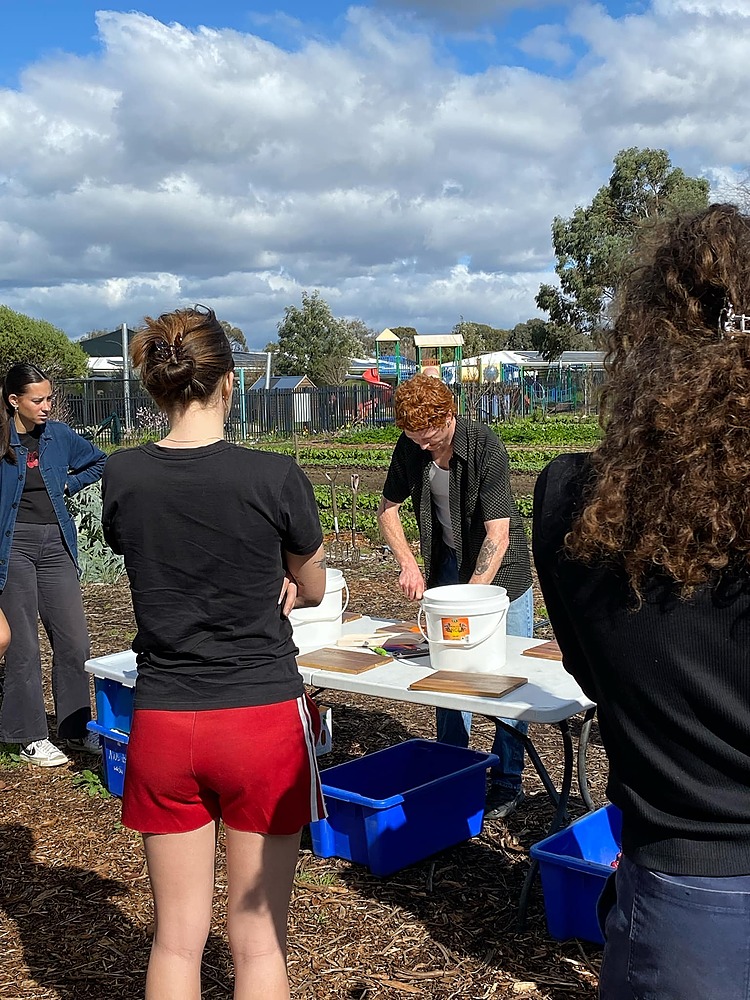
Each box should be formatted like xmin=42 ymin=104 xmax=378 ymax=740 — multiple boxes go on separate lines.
xmin=0 ymin=364 xmax=106 ymax=767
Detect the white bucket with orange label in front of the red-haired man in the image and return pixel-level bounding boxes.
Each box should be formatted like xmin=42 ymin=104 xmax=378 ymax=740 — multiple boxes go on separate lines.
xmin=417 ymin=583 xmax=510 ymax=674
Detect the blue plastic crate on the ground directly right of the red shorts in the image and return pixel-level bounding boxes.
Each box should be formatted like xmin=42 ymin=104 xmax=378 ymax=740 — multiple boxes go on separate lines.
xmin=310 ymin=740 xmax=498 ymax=877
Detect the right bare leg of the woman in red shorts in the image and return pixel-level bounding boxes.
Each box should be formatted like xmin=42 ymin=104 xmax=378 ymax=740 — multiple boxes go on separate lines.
xmin=226 ymin=828 xmax=300 ymax=1000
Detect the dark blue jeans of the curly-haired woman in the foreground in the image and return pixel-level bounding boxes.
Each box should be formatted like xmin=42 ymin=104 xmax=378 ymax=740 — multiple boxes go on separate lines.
xmin=599 ymin=856 xmax=750 ymax=1000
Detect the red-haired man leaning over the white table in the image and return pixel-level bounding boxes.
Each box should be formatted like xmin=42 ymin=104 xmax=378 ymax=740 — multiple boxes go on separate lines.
xmin=378 ymin=374 xmax=534 ymax=819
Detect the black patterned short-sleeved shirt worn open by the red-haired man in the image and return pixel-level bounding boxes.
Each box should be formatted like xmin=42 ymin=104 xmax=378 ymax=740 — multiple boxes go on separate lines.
xmin=383 ymin=417 xmax=531 ymax=601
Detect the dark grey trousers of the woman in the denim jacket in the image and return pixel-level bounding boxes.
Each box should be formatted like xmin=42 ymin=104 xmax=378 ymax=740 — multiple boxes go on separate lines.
xmin=0 ymin=523 xmax=91 ymax=745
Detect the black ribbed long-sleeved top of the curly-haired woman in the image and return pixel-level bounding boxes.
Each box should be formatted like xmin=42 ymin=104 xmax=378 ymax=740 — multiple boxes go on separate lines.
xmin=533 ymin=455 xmax=750 ymax=877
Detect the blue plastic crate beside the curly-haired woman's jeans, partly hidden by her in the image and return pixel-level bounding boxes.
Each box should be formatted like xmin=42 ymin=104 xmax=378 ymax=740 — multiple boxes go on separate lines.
xmin=531 ymin=805 xmax=622 ymax=944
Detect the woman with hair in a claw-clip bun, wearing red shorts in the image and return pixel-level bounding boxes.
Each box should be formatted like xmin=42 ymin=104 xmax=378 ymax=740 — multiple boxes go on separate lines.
xmin=103 ymin=306 xmax=325 ymax=1000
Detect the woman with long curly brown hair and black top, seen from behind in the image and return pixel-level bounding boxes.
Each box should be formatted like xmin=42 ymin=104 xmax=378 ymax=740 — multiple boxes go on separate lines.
xmin=533 ymin=205 xmax=750 ymax=1000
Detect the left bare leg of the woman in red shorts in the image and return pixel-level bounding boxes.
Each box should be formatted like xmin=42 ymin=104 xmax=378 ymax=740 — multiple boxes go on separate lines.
xmin=143 ymin=823 xmax=216 ymax=1000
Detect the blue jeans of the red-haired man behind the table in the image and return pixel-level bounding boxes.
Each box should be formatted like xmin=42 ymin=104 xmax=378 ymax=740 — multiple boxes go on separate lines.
xmin=435 ymin=549 xmax=534 ymax=793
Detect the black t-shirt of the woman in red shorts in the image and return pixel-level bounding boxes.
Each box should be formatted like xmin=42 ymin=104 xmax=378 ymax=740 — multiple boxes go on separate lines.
xmin=102 ymin=441 xmax=323 ymax=711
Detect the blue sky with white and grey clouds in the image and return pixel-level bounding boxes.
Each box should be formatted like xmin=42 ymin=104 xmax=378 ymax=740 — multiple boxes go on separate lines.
xmin=0 ymin=0 xmax=750 ymax=347
